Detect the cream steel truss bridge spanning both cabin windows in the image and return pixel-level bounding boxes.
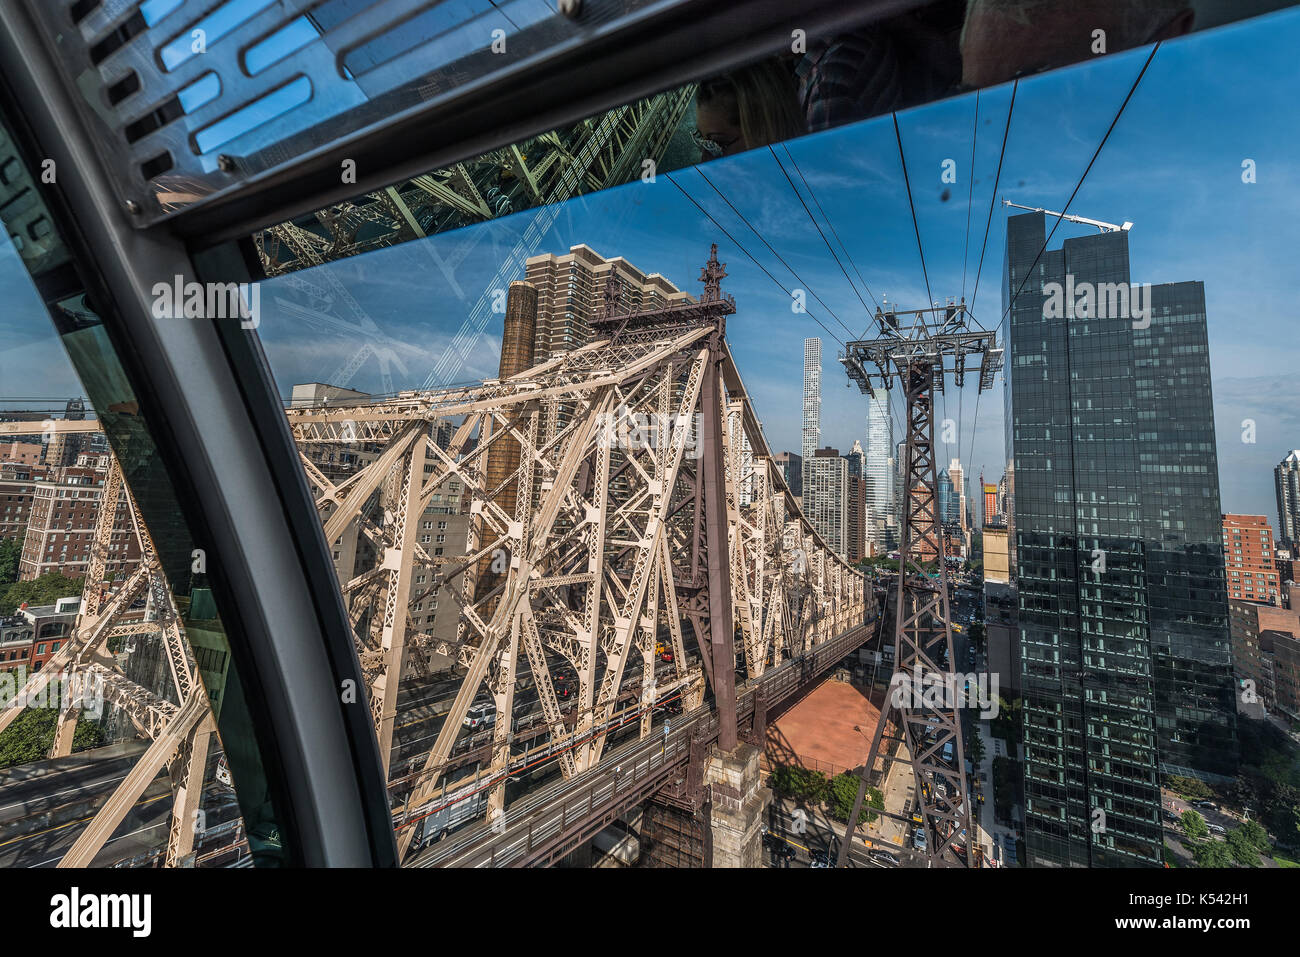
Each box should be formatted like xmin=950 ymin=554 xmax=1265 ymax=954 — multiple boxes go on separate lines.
xmin=0 ymin=246 xmax=875 ymax=866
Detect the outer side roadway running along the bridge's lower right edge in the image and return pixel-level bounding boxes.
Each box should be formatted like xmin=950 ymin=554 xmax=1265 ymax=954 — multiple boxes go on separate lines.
xmin=411 ymin=619 xmax=876 ymax=867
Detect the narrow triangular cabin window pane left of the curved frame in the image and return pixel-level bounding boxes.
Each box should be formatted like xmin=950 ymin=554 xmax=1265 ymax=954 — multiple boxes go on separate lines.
xmin=0 ymin=121 xmax=282 ymax=867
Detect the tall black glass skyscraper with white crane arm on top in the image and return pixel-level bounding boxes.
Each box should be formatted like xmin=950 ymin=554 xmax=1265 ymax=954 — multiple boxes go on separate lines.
xmin=1002 ymin=213 xmax=1236 ymax=867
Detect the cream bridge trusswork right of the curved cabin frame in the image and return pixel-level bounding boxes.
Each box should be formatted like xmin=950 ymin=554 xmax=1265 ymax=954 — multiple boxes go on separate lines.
xmin=286 ymin=244 xmax=866 ymax=856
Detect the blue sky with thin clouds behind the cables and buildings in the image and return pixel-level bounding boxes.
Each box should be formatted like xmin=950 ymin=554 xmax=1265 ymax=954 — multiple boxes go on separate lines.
xmin=0 ymin=1 xmax=1300 ymax=521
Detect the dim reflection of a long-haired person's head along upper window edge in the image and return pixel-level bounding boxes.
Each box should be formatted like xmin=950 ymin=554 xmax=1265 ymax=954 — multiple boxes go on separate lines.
xmin=692 ymin=57 xmax=803 ymax=160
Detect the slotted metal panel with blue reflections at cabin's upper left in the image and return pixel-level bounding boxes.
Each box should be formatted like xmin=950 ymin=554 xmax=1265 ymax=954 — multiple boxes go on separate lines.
xmin=29 ymin=0 xmax=673 ymax=225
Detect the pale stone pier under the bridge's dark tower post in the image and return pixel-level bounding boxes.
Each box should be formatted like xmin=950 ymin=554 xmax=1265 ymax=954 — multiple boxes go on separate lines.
xmin=705 ymin=742 xmax=772 ymax=867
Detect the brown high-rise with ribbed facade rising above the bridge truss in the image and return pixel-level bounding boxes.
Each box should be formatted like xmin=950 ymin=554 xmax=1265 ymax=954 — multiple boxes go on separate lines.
xmin=524 ymin=244 xmax=693 ymax=363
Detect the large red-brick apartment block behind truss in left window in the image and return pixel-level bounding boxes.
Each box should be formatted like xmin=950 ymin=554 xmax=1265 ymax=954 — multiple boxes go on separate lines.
xmin=18 ymin=454 xmax=140 ymax=581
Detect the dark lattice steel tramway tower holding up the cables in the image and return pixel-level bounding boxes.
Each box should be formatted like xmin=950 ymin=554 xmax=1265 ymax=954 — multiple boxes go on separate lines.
xmin=837 ymin=299 xmax=1002 ymax=866
